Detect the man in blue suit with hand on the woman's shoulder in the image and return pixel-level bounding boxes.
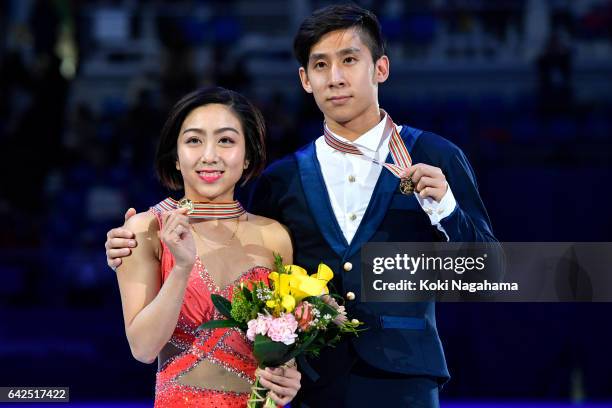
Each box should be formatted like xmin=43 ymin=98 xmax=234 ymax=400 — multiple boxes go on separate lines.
xmin=107 ymin=5 xmax=495 ymax=408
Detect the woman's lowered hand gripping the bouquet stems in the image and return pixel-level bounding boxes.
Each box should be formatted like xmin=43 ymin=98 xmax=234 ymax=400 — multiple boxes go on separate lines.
xmin=255 ymin=360 xmax=302 ymax=405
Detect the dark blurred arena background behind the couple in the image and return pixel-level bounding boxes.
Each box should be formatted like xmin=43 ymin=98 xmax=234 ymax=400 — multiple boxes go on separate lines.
xmin=0 ymin=0 xmax=612 ymax=407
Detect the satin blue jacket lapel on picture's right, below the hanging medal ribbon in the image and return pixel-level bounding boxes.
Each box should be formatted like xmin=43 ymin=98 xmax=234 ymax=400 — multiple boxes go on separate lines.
xmin=344 ymin=126 xmax=422 ymax=258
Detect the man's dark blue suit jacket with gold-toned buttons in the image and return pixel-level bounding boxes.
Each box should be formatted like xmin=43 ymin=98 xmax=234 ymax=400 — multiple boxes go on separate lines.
xmin=250 ymin=126 xmax=495 ymax=382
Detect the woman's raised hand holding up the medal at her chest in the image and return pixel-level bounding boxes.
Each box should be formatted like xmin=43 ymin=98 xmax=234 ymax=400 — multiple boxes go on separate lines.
xmin=159 ymin=208 xmax=197 ymax=272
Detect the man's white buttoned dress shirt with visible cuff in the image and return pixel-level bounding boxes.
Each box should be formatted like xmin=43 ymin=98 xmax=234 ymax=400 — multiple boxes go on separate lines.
xmin=315 ymin=114 xmax=457 ymax=244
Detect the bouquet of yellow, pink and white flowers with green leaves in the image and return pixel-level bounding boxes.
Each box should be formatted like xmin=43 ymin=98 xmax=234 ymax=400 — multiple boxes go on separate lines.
xmin=199 ymin=255 xmax=362 ymax=408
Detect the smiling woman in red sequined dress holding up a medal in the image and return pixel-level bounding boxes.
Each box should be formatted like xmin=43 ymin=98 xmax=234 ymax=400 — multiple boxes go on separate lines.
xmin=117 ymin=88 xmax=300 ymax=407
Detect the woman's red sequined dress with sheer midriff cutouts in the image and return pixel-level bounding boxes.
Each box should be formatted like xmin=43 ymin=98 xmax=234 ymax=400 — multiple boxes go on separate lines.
xmin=151 ymin=207 xmax=270 ymax=408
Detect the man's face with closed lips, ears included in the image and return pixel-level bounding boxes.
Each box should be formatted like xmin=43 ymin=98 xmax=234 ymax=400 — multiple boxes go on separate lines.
xmin=300 ymin=28 xmax=389 ymax=124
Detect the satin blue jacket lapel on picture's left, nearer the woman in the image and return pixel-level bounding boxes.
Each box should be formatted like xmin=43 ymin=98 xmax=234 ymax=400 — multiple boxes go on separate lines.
xmin=295 ymin=142 xmax=348 ymax=256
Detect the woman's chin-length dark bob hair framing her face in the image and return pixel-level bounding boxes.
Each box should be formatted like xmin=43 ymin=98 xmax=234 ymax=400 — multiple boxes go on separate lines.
xmin=155 ymin=87 xmax=266 ymax=190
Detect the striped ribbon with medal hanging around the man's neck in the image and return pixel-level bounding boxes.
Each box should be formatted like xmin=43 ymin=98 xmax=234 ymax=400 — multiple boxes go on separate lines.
xmin=323 ymin=110 xmax=414 ymax=194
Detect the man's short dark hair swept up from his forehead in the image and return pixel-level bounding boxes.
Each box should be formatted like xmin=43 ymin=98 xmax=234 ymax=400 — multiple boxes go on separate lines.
xmin=293 ymin=4 xmax=385 ymax=68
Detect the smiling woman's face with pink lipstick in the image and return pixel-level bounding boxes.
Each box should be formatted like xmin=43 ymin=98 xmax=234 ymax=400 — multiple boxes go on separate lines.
xmin=176 ymin=104 xmax=246 ymax=202
